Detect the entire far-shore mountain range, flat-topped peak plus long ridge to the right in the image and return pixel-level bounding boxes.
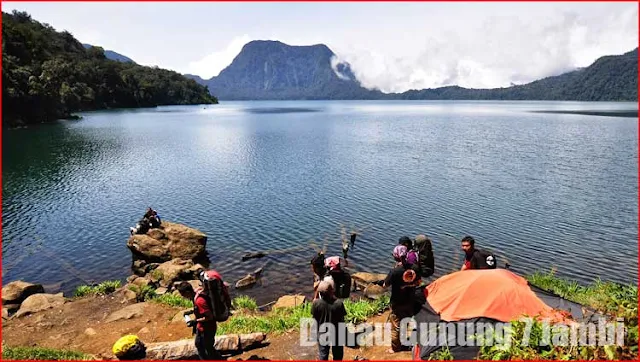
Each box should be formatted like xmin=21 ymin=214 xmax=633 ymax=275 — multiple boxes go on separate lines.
xmin=198 ymin=41 xmax=638 ymax=101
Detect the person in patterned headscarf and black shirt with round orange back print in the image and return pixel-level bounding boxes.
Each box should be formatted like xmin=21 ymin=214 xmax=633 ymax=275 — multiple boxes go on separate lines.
xmin=383 ymin=245 xmax=421 ymax=353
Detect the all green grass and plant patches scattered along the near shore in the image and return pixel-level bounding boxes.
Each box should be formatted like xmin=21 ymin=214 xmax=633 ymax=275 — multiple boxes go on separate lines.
xmin=2 ymin=270 xmax=638 ymax=360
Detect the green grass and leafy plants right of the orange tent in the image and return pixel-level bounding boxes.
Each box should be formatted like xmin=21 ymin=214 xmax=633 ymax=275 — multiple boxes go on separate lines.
xmin=472 ymin=270 xmax=638 ymax=360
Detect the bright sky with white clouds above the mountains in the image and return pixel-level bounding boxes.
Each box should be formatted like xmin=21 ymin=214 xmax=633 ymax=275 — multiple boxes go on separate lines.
xmin=2 ymin=1 xmax=638 ymax=92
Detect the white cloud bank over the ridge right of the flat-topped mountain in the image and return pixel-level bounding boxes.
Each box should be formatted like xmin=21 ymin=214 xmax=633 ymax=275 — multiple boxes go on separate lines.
xmin=334 ymin=6 xmax=638 ymax=92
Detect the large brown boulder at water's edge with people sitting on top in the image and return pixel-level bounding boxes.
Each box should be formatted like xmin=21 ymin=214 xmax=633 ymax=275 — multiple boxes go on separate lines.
xmin=127 ymin=221 xmax=207 ymax=262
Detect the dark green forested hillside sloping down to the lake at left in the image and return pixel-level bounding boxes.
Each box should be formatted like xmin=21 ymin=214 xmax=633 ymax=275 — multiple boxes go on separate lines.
xmin=2 ymin=11 xmax=218 ymax=127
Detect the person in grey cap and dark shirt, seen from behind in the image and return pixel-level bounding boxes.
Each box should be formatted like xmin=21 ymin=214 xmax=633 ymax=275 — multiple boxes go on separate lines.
xmin=311 ymin=280 xmax=347 ymax=361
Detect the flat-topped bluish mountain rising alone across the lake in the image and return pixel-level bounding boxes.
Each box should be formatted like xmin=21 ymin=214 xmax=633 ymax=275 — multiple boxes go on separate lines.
xmin=196 ymin=41 xmax=383 ymax=100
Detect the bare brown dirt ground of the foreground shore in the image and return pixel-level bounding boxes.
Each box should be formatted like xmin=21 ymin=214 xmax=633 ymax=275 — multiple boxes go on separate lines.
xmin=2 ymin=295 xmax=411 ymax=360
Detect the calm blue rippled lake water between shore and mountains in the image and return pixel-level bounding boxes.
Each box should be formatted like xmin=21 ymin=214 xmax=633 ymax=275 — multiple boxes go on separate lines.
xmin=2 ymin=101 xmax=638 ymax=302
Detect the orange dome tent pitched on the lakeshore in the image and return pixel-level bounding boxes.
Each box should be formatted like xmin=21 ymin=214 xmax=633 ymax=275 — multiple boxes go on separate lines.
xmin=427 ymin=269 xmax=566 ymax=322
